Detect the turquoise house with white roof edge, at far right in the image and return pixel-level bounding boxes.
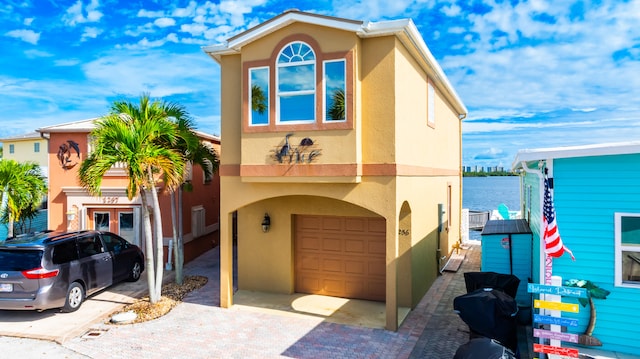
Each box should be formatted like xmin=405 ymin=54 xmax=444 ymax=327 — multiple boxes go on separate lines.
xmin=512 ymin=142 xmax=640 ymax=355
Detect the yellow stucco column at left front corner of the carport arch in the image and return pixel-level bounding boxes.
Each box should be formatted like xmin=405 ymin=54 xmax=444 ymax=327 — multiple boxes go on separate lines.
xmin=220 ymin=211 xmax=233 ymax=308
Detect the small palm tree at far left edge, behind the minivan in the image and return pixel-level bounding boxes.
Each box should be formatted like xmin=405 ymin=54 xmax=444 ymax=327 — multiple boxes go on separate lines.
xmin=0 ymin=160 xmax=47 ymax=237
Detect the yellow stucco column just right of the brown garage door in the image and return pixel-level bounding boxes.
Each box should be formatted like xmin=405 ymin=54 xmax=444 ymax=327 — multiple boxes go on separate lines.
xmin=385 ymin=215 xmax=398 ymax=332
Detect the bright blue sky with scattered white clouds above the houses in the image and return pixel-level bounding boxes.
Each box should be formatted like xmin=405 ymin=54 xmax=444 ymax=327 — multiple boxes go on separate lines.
xmin=0 ymin=0 xmax=640 ymax=167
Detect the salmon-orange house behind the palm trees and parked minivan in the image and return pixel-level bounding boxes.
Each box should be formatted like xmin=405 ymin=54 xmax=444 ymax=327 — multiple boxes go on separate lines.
xmin=37 ymin=119 xmax=220 ymax=262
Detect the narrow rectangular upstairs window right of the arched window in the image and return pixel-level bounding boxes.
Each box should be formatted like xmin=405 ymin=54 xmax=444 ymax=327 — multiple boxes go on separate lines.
xmin=324 ymin=59 xmax=347 ymax=121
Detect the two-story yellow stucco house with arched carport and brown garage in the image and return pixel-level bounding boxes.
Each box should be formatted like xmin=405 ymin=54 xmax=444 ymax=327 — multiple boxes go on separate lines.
xmin=204 ymin=10 xmax=467 ymax=330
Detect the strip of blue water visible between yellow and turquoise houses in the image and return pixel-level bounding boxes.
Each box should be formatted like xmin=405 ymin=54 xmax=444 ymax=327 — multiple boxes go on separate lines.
xmin=462 ymin=176 xmax=520 ymax=240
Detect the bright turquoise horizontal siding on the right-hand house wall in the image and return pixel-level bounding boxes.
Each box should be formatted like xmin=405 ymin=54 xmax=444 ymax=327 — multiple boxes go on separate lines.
xmin=531 ymin=154 xmax=640 ymax=354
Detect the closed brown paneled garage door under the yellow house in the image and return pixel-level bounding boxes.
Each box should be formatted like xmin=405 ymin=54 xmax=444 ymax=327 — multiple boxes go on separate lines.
xmin=294 ymin=216 xmax=386 ymax=301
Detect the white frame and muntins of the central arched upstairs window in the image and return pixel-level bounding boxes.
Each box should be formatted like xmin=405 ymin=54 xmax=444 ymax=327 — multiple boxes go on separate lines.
xmin=275 ymin=41 xmax=318 ymax=125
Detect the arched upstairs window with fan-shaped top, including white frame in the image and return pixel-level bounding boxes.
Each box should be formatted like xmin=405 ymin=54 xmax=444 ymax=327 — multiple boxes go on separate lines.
xmin=276 ymin=41 xmax=316 ymax=123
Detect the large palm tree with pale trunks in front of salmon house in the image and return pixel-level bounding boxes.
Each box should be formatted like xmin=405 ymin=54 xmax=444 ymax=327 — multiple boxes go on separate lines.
xmin=79 ymin=94 xmax=184 ymax=303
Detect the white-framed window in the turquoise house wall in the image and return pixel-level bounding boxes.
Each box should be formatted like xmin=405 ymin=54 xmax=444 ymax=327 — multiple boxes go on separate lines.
xmin=615 ymin=213 xmax=640 ymax=288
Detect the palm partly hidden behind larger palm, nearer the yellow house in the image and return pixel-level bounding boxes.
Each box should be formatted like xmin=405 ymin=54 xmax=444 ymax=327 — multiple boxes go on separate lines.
xmin=164 ymin=113 xmax=219 ymax=285
